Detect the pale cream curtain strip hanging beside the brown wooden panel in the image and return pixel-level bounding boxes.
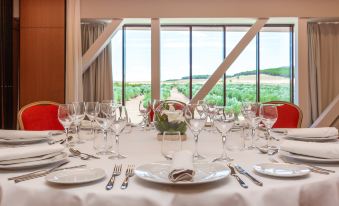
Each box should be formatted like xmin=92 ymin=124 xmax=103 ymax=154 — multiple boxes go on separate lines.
xmin=66 ymin=0 xmax=83 ymax=103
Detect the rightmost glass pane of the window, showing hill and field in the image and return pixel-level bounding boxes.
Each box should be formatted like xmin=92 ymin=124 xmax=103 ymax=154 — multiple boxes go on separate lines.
xmin=260 ymin=27 xmax=291 ymax=102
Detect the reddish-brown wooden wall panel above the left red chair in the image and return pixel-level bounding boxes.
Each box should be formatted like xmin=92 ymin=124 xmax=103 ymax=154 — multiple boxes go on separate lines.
xmin=19 ymin=0 xmax=65 ymax=107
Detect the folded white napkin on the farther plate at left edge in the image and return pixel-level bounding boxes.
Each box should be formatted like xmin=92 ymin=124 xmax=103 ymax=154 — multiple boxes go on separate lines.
xmin=0 ymin=129 xmax=50 ymax=139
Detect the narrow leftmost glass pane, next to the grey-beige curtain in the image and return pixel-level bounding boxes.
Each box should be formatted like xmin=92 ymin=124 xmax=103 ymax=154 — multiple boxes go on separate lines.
xmin=111 ymin=30 xmax=122 ymax=103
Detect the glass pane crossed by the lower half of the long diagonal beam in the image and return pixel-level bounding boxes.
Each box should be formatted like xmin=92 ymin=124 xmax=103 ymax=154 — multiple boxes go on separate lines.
xmin=192 ymin=27 xmax=224 ymax=105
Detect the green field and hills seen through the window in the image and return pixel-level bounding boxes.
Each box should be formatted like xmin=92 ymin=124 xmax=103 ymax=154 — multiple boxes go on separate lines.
xmin=113 ymin=67 xmax=290 ymax=113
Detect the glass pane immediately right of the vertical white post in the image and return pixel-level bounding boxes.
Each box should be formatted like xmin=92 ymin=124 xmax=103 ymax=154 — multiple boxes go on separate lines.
xmin=160 ymin=27 xmax=190 ymax=103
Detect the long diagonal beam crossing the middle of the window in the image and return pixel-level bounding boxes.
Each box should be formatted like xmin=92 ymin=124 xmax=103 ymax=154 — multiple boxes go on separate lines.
xmin=191 ymin=18 xmax=268 ymax=103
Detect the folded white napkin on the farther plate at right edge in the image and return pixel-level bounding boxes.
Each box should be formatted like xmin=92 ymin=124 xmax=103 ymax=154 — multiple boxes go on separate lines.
xmin=287 ymin=127 xmax=338 ymax=138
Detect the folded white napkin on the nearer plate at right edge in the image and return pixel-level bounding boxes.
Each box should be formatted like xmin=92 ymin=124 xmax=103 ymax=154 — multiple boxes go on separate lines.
xmin=280 ymin=140 xmax=339 ymax=159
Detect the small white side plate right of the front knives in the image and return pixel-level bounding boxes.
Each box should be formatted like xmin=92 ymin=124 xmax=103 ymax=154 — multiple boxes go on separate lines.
xmin=253 ymin=163 xmax=310 ymax=177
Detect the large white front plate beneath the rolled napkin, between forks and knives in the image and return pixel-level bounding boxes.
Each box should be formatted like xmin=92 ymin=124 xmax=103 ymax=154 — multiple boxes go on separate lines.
xmin=135 ymin=161 xmax=230 ymax=185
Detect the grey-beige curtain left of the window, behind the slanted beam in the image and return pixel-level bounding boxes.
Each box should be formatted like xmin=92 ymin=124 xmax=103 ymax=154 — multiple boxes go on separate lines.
xmin=81 ymin=23 xmax=113 ymax=101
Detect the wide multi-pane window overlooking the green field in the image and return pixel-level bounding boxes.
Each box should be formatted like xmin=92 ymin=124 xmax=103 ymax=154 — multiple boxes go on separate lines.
xmin=112 ymin=25 xmax=294 ymax=119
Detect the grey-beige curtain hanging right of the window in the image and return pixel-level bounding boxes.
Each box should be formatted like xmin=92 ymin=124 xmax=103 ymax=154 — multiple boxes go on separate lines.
xmin=308 ymin=23 xmax=339 ymax=122
